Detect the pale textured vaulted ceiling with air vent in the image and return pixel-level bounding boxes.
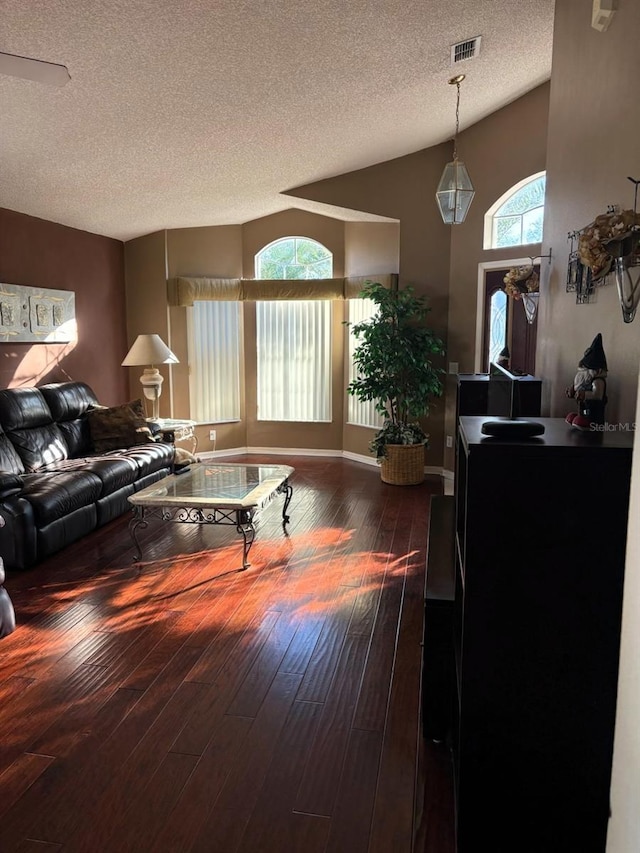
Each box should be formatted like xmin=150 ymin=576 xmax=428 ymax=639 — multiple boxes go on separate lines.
xmin=0 ymin=0 xmax=554 ymax=240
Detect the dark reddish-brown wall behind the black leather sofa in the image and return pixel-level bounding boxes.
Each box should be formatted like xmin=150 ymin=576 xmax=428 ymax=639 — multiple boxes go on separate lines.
xmin=0 ymin=209 xmax=128 ymax=405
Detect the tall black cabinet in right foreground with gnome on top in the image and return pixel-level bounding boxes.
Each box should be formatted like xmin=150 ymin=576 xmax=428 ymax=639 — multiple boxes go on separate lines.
xmin=452 ymin=417 xmax=633 ymax=853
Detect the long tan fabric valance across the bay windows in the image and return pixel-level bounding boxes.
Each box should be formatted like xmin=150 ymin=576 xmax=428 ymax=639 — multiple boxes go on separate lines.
xmin=169 ymin=273 xmax=398 ymax=307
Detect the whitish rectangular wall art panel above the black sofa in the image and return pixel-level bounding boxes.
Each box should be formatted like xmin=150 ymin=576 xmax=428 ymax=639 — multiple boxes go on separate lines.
xmin=0 ymin=284 xmax=77 ymax=344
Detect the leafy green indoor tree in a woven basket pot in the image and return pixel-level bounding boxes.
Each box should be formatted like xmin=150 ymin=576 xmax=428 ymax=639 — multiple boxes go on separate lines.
xmin=347 ymin=281 xmax=444 ymax=485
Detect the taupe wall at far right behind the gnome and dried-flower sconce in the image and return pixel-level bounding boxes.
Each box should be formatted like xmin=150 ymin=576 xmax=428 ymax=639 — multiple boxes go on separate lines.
xmin=537 ymin=0 xmax=640 ymax=430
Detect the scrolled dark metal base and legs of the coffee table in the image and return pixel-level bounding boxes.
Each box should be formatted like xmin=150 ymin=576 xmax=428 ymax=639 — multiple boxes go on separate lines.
xmin=129 ymin=480 xmax=293 ymax=569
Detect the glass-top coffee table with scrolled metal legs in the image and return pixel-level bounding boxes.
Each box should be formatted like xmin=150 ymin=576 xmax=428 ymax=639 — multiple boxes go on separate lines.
xmin=129 ymin=462 xmax=294 ymax=569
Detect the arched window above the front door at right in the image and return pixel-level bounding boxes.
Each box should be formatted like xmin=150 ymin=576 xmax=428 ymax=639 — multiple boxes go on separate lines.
xmin=484 ymin=172 xmax=546 ymax=249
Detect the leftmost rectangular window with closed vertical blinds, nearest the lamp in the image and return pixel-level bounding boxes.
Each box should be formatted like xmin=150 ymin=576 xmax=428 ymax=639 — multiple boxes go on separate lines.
xmin=187 ymin=301 xmax=240 ymax=423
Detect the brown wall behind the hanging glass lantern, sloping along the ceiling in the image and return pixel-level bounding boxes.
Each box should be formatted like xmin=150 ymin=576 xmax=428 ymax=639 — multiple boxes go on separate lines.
xmin=291 ymin=90 xmax=549 ymax=469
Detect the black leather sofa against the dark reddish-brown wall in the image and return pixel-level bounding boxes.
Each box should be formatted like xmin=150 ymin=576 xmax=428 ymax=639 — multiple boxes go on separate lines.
xmin=0 ymin=382 xmax=174 ymax=570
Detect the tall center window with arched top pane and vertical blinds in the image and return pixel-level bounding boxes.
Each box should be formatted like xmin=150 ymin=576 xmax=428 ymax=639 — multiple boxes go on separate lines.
xmin=255 ymin=237 xmax=333 ymax=422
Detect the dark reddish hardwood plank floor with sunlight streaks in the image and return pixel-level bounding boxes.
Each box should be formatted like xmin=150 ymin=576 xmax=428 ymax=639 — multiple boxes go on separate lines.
xmin=0 ymin=456 xmax=453 ymax=853
